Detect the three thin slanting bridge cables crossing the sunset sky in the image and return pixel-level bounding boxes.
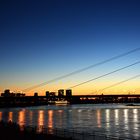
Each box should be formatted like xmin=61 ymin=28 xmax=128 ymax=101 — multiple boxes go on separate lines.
xmin=20 ymin=48 xmax=140 ymax=97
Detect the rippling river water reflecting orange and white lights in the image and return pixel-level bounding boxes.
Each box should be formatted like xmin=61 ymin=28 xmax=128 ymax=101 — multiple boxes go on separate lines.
xmin=0 ymin=104 xmax=140 ymax=139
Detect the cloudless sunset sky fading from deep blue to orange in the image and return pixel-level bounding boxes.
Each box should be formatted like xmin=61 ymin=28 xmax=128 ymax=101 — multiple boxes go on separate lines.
xmin=0 ymin=0 xmax=140 ymax=95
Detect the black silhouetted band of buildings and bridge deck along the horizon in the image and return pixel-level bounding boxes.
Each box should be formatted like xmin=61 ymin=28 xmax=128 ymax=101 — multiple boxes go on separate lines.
xmin=0 ymin=89 xmax=140 ymax=107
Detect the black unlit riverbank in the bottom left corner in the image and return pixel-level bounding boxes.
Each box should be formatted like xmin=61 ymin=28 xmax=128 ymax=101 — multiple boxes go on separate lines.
xmin=0 ymin=121 xmax=71 ymax=140
